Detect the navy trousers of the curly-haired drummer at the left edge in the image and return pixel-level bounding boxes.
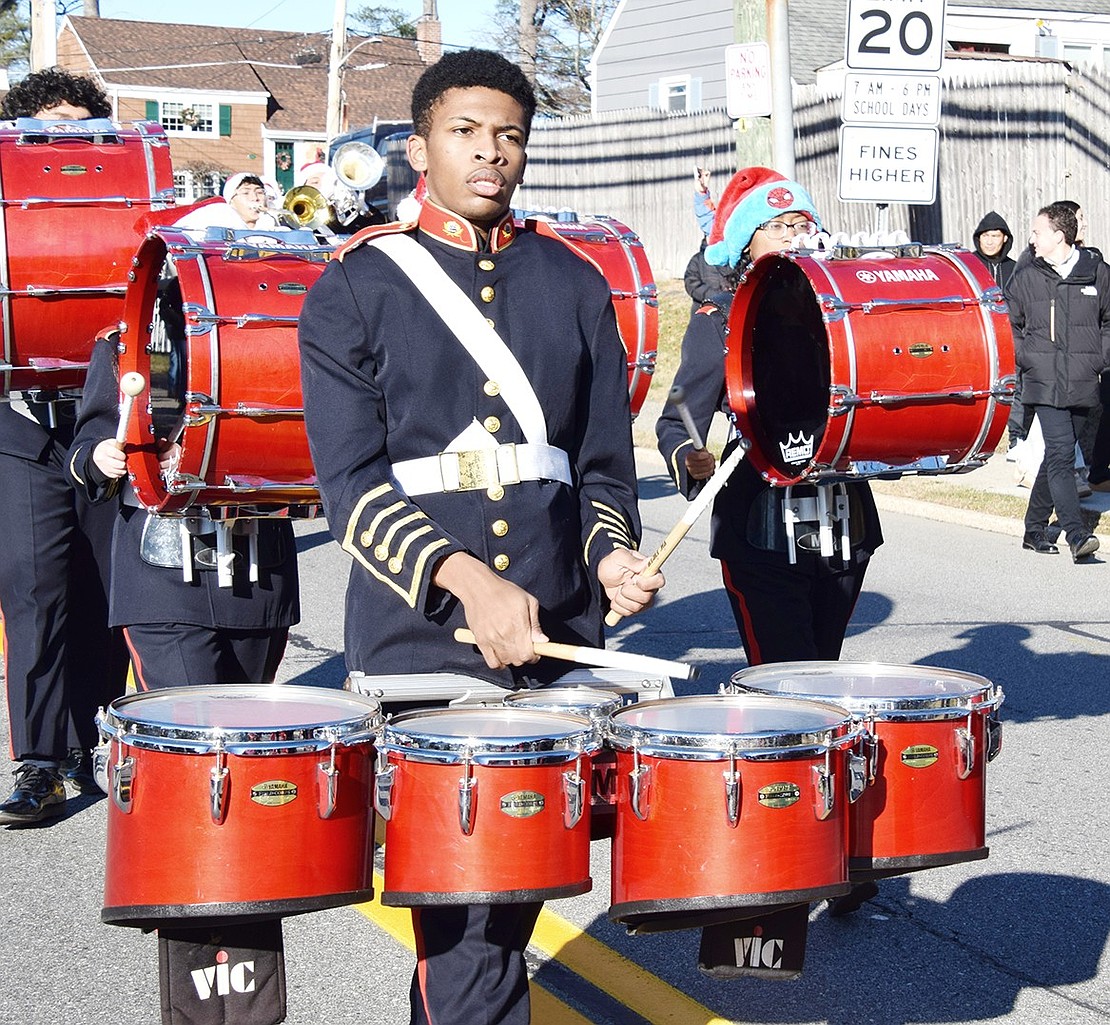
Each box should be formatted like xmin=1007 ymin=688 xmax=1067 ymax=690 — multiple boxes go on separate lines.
xmin=0 ymin=404 xmax=128 ymax=762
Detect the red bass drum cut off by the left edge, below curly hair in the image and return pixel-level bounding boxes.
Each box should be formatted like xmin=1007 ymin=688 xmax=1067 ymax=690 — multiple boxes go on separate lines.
xmin=0 ymin=118 xmax=174 ymax=395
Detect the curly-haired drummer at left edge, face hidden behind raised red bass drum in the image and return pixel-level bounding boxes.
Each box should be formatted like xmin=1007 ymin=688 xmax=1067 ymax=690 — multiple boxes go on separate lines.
xmin=0 ymin=68 xmax=128 ymax=825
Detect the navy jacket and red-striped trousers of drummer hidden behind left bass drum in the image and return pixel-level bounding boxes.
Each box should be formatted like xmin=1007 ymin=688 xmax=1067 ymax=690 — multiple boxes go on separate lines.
xmin=65 ymin=339 xmax=300 ymax=690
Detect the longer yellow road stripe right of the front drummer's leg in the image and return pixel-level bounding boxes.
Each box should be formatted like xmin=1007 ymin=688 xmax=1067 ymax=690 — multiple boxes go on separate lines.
xmin=532 ymin=907 xmax=731 ymax=1025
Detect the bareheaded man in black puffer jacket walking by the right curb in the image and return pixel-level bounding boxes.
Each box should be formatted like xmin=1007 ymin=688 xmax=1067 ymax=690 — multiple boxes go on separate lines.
xmin=1009 ymin=203 xmax=1110 ymax=562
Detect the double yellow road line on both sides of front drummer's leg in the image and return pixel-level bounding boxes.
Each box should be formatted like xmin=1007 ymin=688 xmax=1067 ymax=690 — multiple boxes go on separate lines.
xmin=357 ymin=872 xmax=731 ymax=1025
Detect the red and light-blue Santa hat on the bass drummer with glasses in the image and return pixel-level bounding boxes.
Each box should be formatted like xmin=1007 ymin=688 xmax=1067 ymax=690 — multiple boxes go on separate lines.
xmin=705 ymin=168 xmax=820 ymax=267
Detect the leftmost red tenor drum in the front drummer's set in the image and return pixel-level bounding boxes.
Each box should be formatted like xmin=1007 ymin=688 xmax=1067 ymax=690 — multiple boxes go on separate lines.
xmin=98 ymin=685 xmax=381 ymax=928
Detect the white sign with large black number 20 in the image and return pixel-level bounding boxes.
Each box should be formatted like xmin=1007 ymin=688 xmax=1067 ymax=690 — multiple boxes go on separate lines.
xmin=845 ymin=0 xmax=945 ymax=71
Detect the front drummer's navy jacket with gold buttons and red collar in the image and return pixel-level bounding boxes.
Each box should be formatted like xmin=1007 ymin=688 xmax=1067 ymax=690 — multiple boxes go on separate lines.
xmin=300 ymin=202 xmax=639 ymax=686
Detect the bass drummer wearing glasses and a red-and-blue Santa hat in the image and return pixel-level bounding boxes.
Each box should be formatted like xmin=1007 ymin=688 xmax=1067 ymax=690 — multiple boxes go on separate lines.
xmin=655 ymin=167 xmax=882 ymax=914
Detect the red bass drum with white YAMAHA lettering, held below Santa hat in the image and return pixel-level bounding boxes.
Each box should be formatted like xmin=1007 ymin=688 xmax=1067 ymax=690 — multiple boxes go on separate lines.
xmin=725 ymin=245 xmax=1015 ymax=484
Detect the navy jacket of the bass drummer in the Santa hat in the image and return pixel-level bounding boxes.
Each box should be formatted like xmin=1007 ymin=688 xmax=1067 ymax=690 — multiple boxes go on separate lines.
xmin=655 ymin=285 xmax=882 ymax=564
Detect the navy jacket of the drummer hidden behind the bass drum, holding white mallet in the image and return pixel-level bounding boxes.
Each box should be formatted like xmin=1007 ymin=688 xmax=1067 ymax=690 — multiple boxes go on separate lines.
xmin=67 ymin=340 xmax=301 ymax=630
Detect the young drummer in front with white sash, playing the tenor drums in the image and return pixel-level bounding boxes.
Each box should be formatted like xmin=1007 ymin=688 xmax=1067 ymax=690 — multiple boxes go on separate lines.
xmin=300 ymin=50 xmax=663 ymax=1025
